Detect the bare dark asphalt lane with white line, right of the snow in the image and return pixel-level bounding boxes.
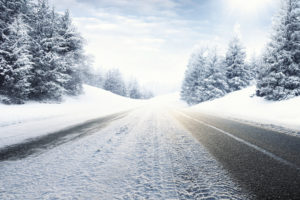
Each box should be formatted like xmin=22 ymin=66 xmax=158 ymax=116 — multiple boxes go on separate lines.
xmin=173 ymin=111 xmax=300 ymax=200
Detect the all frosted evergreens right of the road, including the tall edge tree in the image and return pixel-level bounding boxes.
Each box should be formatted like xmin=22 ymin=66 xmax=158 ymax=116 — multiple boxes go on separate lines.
xmin=181 ymin=0 xmax=300 ymax=105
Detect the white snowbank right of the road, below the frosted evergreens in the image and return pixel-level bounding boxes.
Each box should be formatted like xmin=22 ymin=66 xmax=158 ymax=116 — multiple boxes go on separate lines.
xmin=192 ymin=86 xmax=300 ymax=135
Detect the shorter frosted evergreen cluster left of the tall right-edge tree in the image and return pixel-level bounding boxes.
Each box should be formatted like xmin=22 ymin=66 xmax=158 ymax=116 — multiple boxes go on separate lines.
xmin=181 ymin=37 xmax=256 ymax=105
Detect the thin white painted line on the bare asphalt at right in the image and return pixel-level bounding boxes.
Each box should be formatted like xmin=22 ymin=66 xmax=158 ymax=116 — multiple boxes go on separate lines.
xmin=175 ymin=111 xmax=300 ymax=171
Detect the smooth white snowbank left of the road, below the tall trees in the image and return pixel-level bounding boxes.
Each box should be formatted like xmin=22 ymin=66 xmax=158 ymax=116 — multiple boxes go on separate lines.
xmin=0 ymin=85 xmax=143 ymax=148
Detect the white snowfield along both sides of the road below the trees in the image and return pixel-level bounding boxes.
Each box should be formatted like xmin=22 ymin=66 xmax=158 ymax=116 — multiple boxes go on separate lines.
xmin=0 ymin=85 xmax=300 ymax=147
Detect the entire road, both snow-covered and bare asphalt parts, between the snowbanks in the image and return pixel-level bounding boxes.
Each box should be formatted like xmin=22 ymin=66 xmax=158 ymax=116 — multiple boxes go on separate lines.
xmin=0 ymin=106 xmax=300 ymax=200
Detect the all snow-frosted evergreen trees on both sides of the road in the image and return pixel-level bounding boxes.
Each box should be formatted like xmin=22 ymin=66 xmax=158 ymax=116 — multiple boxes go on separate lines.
xmin=0 ymin=0 xmax=300 ymax=105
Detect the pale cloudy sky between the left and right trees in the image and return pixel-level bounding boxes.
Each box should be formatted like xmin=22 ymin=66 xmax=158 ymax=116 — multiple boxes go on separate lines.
xmin=49 ymin=0 xmax=279 ymax=93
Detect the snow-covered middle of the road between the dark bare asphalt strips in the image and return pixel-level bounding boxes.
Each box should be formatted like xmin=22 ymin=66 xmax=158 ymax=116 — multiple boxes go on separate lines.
xmin=0 ymin=106 xmax=248 ymax=199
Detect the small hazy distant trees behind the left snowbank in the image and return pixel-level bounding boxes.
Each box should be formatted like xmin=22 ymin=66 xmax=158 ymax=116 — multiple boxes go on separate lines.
xmin=82 ymin=68 xmax=154 ymax=99
